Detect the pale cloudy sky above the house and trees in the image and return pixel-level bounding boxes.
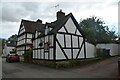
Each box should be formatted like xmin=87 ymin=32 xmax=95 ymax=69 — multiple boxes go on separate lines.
xmin=0 ymin=0 xmax=119 ymax=39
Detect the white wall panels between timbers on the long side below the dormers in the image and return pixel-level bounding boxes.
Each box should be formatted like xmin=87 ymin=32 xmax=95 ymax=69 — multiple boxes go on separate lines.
xmin=33 ymin=35 xmax=54 ymax=59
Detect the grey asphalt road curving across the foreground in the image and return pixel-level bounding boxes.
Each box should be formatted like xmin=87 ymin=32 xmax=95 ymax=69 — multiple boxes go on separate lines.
xmin=2 ymin=57 xmax=118 ymax=78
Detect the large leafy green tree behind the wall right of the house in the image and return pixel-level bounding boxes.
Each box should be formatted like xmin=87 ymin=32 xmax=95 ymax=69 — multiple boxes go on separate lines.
xmin=79 ymin=16 xmax=116 ymax=45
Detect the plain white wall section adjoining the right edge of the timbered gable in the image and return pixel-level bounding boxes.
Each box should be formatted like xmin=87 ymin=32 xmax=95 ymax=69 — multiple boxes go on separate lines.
xmin=85 ymin=42 xmax=96 ymax=58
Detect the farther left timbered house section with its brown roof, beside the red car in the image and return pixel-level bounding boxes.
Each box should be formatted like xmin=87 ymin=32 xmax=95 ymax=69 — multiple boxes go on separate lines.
xmin=17 ymin=19 xmax=42 ymax=55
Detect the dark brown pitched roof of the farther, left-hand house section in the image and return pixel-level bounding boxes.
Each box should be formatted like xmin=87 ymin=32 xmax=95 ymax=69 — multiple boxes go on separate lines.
xmin=21 ymin=19 xmax=44 ymax=33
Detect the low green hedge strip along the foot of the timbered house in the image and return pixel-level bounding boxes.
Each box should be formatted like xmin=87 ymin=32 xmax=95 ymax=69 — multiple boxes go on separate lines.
xmin=32 ymin=57 xmax=105 ymax=69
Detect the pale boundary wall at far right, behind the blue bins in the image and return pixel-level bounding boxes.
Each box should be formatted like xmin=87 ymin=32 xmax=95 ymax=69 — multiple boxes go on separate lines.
xmin=96 ymin=43 xmax=118 ymax=56
